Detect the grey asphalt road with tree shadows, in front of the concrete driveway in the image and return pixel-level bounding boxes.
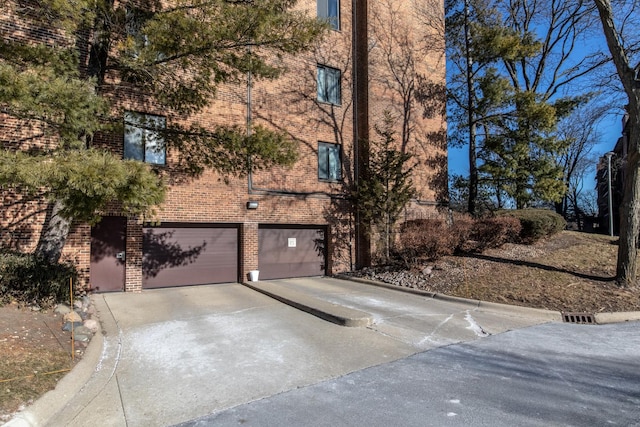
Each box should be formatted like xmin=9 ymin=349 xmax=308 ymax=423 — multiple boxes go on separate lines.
xmin=180 ymin=322 xmax=640 ymax=427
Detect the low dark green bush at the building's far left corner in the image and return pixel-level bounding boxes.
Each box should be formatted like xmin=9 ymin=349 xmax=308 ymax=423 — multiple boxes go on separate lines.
xmin=0 ymin=252 xmax=78 ymax=308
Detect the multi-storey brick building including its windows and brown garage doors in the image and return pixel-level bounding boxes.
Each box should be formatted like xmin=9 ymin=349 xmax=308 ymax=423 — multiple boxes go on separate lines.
xmin=0 ymin=0 xmax=447 ymax=292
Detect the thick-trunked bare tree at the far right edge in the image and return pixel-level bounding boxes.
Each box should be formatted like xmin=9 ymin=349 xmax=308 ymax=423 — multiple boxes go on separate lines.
xmin=594 ymin=0 xmax=640 ymax=286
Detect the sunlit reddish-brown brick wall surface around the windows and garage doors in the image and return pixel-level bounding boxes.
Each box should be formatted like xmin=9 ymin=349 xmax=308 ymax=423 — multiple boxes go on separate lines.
xmin=0 ymin=0 xmax=446 ymax=291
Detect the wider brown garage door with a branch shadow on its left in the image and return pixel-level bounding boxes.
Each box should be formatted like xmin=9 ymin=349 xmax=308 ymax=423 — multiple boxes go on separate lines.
xmin=142 ymin=224 xmax=238 ymax=288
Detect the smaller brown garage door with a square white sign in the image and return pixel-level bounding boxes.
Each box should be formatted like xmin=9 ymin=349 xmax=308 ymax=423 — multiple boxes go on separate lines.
xmin=258 ymin=225 xmax=326 ymax=280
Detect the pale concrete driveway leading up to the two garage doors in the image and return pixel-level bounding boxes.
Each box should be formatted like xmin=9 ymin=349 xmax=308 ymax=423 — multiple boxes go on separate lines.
xmin=10 ymin=278 xmax=576 ymax=426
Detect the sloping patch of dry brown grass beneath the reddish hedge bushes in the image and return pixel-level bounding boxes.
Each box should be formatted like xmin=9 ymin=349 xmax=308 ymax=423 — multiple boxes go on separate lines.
xmin=402 ymin=231 xmax=640 ymax=313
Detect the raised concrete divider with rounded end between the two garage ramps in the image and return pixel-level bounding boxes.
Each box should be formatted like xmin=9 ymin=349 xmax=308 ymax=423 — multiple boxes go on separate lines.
xmin=243 ymin=282 xmax=373 ymax=327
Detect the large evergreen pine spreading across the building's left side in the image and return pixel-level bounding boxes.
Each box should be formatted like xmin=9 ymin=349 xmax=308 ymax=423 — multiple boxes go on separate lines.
xmin=0 ymin=0 xmax=327 ymax=260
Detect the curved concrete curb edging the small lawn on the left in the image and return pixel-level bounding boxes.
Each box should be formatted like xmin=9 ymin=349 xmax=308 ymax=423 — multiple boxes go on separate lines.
xmin=3 ymin=305 xmax=104 ymax=427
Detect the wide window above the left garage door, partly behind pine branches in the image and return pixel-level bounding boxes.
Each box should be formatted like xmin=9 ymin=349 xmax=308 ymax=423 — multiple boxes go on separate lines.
xmin=124 ymin=111 xmax=167 ymax=165
